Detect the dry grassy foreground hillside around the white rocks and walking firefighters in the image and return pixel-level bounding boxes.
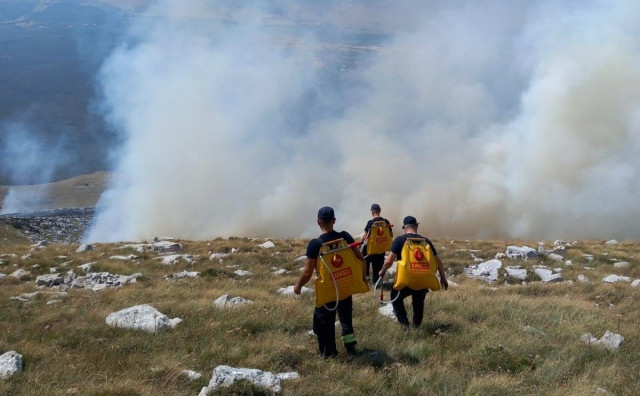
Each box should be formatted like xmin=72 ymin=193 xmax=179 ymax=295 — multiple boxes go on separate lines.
xmin=0 ymin=238 xmax=640 ymax=395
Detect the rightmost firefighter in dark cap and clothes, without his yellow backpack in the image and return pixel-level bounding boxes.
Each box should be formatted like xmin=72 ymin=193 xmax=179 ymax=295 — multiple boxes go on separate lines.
xmin=380 ymin=216 xmax=449 ymax=330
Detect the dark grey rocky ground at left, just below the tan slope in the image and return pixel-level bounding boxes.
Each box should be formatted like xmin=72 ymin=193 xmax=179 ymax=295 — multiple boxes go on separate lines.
xmin=0 ymin=208 xmax=95 ymax=244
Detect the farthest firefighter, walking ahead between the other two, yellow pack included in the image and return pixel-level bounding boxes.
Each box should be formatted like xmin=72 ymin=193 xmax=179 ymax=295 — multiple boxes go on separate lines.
xmin=362 ymin=204 xmax=393 ymax=284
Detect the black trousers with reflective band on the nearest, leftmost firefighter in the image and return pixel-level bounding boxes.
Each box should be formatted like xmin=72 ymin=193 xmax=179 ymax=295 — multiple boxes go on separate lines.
xmin=313 ymin=296 xmax=357 ymax=357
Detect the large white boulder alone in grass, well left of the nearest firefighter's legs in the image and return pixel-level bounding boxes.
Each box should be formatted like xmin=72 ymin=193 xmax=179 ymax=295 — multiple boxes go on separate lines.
xmin=106 ymin=304 xmax=179 ymax=333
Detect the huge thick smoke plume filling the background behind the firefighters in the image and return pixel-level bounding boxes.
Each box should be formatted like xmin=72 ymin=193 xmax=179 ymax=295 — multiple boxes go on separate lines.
xmin=87 ymin=0 xmax=640 ymax=241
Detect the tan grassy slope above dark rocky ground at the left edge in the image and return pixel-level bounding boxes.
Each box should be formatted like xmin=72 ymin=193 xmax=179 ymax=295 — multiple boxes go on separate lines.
xmin=0 ymin=172 xmax=109 ymax=210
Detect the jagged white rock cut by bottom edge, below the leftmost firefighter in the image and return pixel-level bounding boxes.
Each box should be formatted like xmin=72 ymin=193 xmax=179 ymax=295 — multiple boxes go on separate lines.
xmin=198 ymin=365 xmax=299 ymax=396
